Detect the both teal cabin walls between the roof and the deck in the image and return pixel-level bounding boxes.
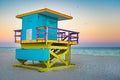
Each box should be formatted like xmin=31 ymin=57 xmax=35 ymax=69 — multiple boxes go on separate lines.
xmin=22 ymin=14 xmax=58 ymax=40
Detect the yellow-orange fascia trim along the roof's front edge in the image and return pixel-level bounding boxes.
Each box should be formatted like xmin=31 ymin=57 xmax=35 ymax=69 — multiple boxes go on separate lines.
xmin=16 ymin=8 xmax=73 ymax=19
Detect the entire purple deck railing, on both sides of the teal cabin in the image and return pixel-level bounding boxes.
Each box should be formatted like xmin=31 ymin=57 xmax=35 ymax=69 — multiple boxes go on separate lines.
xmin=14 ymin=26 xmax=79 ymax=44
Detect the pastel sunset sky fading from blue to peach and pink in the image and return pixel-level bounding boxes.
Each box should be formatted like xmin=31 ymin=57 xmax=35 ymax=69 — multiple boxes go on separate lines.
xmin=0 ymin=0 xmax=120 ymax=47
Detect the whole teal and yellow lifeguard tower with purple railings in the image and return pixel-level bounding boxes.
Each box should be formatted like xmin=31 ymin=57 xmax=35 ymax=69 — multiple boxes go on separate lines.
xmin=14 ymin=8 xmax=79 ymax=72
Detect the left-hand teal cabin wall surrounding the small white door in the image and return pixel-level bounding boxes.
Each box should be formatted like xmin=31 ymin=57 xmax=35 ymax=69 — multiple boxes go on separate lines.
xmin=22 ymin=14 xmax=38 ymax=40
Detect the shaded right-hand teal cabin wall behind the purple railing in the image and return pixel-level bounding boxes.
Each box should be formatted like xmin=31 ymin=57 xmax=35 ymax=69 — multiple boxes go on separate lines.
xmin=38 ymin=15 xmax=58 ymax=40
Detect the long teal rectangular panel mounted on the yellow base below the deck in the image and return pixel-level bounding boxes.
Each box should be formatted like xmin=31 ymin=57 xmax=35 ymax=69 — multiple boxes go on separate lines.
xmin=16 ymin=49 xmax=49 ymax=61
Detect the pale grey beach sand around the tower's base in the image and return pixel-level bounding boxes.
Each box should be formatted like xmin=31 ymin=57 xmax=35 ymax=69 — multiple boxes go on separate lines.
xmin=0 ymin=51 xmax=120 ymax=80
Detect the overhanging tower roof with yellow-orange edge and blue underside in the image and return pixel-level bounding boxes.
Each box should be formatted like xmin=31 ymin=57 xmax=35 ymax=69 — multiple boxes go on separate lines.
xmin=16 ymin=8 xmax=73 ymax=20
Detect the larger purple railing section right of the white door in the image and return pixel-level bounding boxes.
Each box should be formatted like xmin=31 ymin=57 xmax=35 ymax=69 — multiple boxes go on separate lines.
xmin=36 ymin=26 xmax=79 ymax=43
